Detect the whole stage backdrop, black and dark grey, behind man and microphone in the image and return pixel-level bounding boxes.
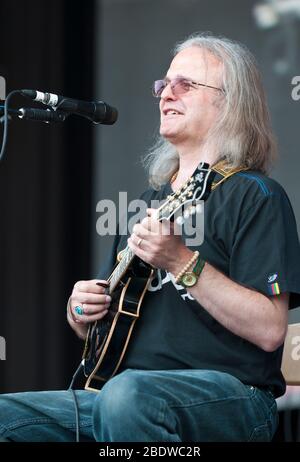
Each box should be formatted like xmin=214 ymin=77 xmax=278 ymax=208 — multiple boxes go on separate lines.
xmin=0 ymin=0 xmax=300 ymax=442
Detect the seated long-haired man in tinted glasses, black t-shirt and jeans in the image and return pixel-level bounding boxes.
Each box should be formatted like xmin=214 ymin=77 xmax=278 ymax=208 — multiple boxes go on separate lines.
xmin=0 ymin=34 xmax=300 ymax=442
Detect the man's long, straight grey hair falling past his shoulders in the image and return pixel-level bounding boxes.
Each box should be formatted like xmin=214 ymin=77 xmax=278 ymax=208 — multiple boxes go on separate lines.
xmin=143 ymin=34 xmax=277 ymax=189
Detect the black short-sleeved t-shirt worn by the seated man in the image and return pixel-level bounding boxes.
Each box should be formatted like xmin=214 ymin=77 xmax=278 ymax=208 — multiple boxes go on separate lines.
xmin=99 ymin=171 xmax=300 ymax=396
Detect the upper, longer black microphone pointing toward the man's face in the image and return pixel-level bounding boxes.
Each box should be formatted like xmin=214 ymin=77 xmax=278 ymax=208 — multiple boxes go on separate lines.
xmin=21 ymin=90 xmax=118 ymax=125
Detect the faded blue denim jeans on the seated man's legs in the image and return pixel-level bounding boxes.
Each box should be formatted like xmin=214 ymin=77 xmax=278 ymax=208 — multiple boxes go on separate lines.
xmin=0 ymin=369 xmax=278 ymax=442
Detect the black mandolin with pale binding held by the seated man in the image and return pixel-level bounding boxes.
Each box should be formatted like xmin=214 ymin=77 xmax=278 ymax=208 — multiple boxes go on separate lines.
xmin=83 ymin=162 xmax=215 ymax=391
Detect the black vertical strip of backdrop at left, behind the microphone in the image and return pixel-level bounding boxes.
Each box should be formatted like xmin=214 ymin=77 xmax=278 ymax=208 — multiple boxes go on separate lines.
xmin=0 ymin=0 xmax=95 ymax=391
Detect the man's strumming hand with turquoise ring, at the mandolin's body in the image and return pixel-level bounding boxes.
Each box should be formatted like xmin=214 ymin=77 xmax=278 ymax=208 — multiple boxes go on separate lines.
xmin=67 ymin=279 xmax=111 ymax=338
